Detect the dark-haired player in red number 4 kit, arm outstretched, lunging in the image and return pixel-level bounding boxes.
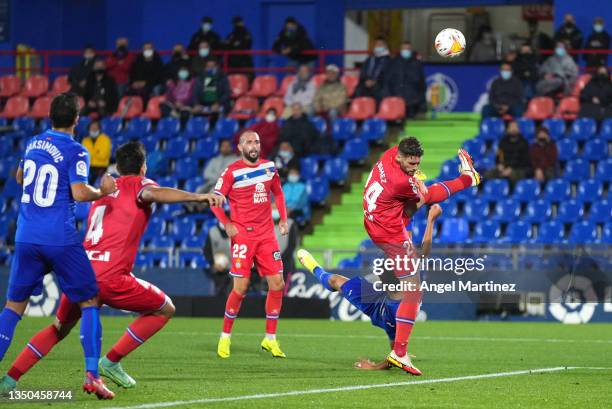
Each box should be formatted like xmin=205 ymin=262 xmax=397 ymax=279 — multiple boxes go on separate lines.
xmin=2 ymin=142 xmax=223 ymax=388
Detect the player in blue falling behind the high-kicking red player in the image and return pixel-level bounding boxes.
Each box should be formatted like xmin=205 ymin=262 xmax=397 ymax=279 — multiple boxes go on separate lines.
xmin=297 ymin=204 xmax=442 ymax=369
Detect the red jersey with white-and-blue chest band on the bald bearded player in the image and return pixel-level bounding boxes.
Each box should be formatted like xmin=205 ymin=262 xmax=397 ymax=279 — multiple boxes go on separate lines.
xmin=214 ymin=159 xmax=284 ymax=236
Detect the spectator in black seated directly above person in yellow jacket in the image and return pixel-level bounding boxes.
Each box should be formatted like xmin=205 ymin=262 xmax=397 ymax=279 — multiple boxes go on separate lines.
xmin=83 ymin=60 xmax=119 ymax=117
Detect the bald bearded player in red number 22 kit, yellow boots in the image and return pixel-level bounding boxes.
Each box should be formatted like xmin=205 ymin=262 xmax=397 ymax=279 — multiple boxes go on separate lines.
xmin=213 ymin=131 xmax=289 ymax=358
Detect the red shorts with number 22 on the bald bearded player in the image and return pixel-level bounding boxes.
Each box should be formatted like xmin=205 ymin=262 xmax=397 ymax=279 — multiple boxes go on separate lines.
xmin=230 ymin=234 xmax=283 ymax=278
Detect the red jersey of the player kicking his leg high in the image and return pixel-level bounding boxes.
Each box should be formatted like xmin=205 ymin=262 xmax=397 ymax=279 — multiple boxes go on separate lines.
xmin=363 ymin=146 xmax=421 ymax=243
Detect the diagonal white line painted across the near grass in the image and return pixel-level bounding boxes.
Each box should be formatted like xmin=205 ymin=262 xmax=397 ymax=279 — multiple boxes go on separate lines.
xmin=106 ymin=366 xmax=584 ymax=409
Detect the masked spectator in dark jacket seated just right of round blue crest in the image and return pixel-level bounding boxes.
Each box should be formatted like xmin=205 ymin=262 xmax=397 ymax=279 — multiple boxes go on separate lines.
xmin=482 ymin=62 xmax=523 ymax=118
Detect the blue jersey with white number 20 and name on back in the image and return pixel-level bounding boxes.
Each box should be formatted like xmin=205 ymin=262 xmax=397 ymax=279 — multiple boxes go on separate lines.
xmin=15 ymin=130 xmax=89 ymax=246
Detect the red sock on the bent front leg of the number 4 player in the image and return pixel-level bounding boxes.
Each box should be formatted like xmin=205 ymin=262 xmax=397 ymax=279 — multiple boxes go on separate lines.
xmin=106 ymin=314 xmax=169 ymax=362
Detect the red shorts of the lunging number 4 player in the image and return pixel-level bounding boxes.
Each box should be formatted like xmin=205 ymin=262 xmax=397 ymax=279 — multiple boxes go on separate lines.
xmin=56 ymin=274 xmax=168 ymax=323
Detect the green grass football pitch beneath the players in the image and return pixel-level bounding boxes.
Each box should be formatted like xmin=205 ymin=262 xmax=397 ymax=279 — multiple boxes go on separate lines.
xmin=0 ymin=317 xmax=612 ymax=409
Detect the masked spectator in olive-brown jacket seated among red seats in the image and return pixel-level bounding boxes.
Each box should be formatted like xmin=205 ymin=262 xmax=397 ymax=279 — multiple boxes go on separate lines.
xmin=314 ymin=64 xmax=348 ymax=119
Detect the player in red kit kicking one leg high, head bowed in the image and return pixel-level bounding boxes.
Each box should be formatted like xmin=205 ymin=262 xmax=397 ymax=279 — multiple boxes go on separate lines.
xmin=363 ymin=137 xmax=480 ymax=375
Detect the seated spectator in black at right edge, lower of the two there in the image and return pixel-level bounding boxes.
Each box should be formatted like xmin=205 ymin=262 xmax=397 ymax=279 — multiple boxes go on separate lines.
xmin=580 ymin=65 xmax=612 ymax=121
